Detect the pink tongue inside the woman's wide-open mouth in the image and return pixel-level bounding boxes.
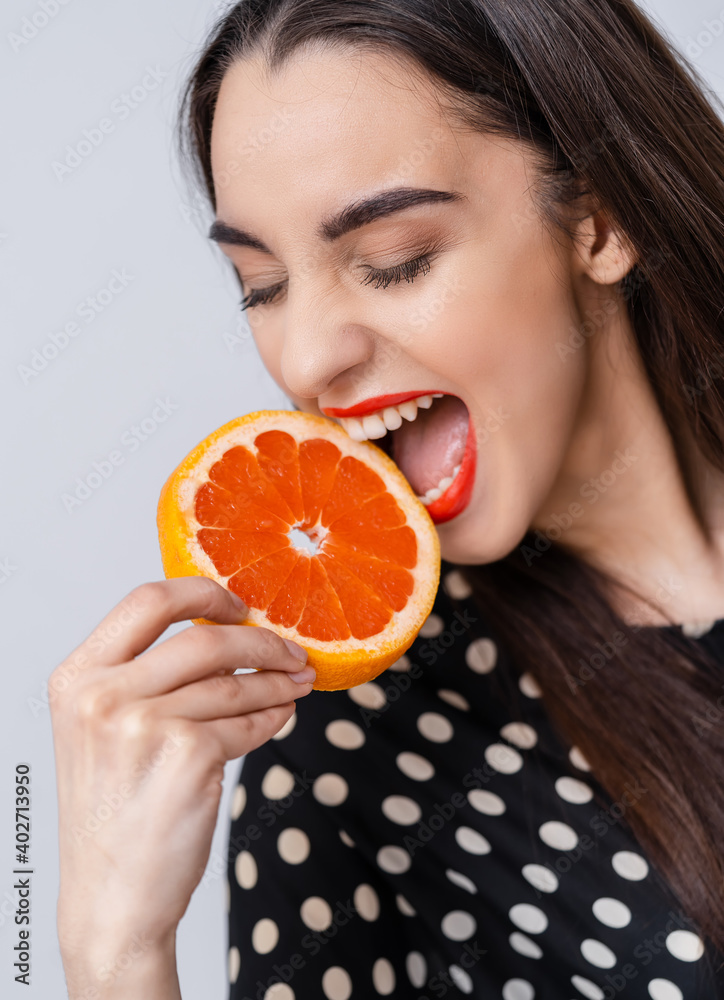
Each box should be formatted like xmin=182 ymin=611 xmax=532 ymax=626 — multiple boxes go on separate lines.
xmin=391 ymin=396 xmax=468 ymax=496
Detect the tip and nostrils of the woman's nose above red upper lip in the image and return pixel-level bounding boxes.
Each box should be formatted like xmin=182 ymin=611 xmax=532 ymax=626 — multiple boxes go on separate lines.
xmin=280 ymin=293 xmax=375 ymax=399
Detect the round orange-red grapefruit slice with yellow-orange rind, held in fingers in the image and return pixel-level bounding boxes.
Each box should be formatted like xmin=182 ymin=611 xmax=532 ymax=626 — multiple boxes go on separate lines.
xmin=157 ymin=410 xmax=440 ymax=691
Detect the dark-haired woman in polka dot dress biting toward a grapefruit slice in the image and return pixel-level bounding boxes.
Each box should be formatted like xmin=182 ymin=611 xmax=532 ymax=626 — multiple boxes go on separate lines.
xmin=51 ymin=0 xmax=724 ymax=1000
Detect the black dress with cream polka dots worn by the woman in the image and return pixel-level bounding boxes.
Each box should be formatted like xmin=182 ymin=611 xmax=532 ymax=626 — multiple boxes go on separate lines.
xmin=228 ymin=561 xmax=724 ymax=1000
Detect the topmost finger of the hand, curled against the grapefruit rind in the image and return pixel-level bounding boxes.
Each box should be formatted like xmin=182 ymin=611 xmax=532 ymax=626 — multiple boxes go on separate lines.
xmin=71 ymin=576 xmax=249 ymax=666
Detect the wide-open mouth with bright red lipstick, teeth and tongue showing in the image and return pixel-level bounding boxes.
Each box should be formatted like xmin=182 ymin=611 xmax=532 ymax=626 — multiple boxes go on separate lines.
xmin=328 ymin=393 xmax=474 ymax=523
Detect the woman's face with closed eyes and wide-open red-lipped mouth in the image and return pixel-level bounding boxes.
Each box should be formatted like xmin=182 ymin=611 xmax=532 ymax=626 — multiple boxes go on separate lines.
xmin=212 ymin=49 xmax=590 ymax=564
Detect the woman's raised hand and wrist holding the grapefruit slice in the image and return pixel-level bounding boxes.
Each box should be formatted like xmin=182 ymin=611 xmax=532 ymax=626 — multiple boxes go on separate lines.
xmin=49 ymin=576 xmax=314 ymax=1000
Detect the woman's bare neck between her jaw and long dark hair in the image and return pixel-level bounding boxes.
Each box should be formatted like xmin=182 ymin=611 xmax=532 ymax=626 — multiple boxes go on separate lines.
xmin=532 ymin=292 xmax=724 ymax=625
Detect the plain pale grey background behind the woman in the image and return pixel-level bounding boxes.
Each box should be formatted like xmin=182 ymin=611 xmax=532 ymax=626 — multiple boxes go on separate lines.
xmin=0 ymin=0 xmax=724 ymax=1000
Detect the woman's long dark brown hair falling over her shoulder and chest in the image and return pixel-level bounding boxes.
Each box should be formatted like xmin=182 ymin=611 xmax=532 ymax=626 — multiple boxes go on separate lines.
xmin=179 ymin=0 xmax=724 ymax=951
